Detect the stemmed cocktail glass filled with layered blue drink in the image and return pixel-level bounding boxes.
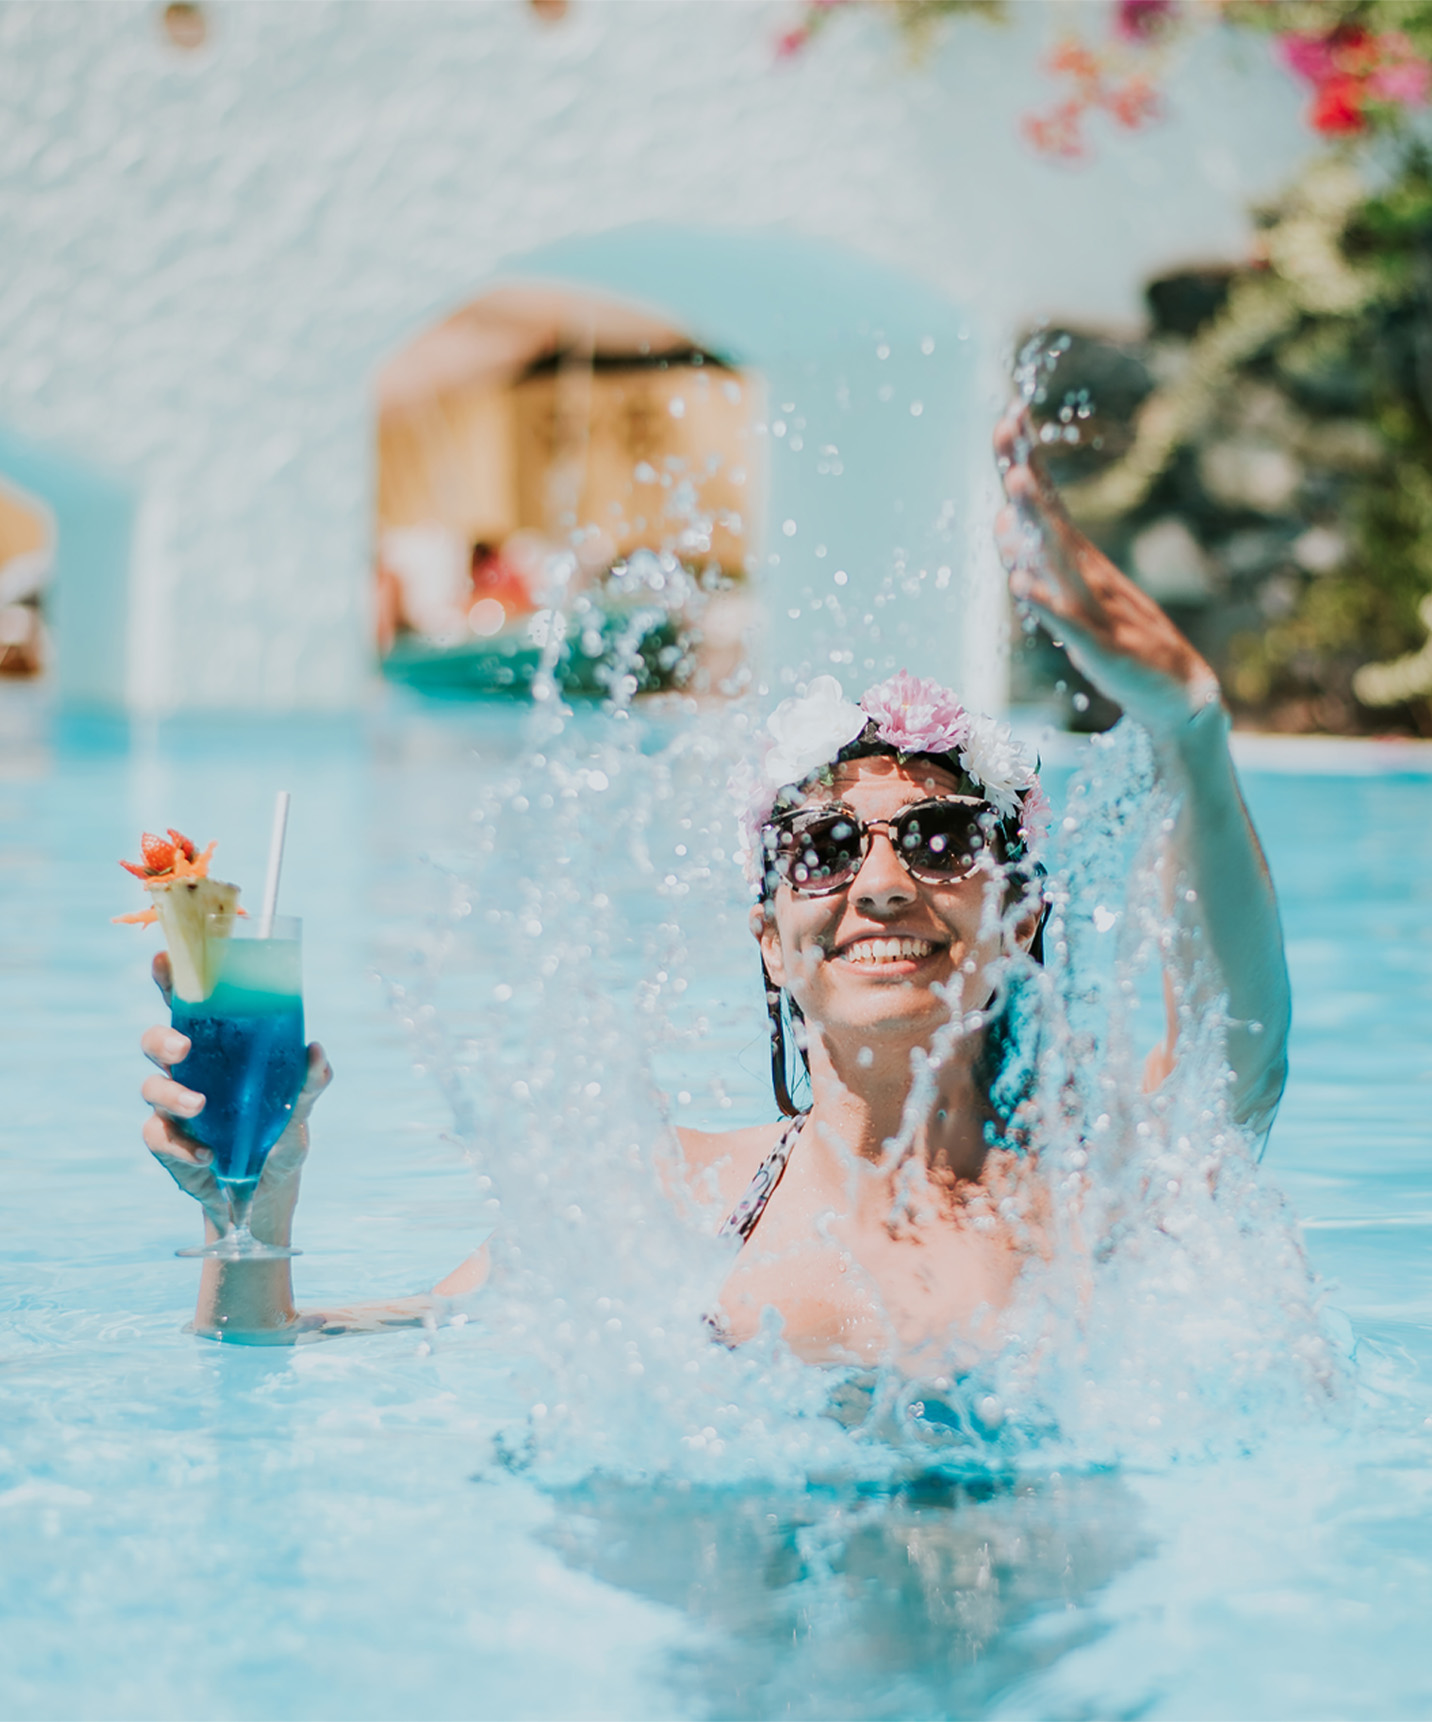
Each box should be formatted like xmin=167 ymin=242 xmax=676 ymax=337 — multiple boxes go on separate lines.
xmin=170 ymin=914 xmax=308 ymax=1262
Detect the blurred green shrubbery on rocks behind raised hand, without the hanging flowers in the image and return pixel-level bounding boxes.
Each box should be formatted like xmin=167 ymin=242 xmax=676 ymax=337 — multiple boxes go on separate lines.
xmin=1032 ymin=150 xmax=1432 ymax=734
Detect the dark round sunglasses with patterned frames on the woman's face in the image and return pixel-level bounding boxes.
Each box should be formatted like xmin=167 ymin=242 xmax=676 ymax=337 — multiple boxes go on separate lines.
xmin=762 ymin=796 xmax=1003 ymax=897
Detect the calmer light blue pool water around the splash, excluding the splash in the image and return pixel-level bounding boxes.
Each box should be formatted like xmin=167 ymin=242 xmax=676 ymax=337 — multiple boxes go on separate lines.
xmin=0 ymin=701 xmax=1432 ymax=1717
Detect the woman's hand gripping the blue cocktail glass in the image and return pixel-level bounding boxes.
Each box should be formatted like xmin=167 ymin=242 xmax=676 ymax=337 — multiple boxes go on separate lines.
xmin=139 ymin=951 xmax=334 ymax=1245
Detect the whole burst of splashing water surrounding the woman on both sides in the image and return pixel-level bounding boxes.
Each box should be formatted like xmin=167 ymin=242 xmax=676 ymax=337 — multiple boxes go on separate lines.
xmin=397 ymin=696 xmax=1349 ymax=1484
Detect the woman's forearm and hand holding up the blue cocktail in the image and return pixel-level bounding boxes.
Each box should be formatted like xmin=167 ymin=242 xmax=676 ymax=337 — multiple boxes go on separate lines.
xmin=139 ymin=952 xmax=489 ymax=1345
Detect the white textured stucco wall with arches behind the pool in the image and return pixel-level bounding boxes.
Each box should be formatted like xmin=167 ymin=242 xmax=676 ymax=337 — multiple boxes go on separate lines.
xmin=0 ymin=0 xmax=1303 ymax=708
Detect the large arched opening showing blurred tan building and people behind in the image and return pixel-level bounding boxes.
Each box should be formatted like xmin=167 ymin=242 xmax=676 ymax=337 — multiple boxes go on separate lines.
xmin=377 ymin=282 xmax=762 ymax=694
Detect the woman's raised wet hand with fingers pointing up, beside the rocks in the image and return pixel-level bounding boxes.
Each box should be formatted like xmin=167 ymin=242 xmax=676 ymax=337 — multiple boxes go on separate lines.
xmin=995 ymin=413 xmax=1219 ymax=740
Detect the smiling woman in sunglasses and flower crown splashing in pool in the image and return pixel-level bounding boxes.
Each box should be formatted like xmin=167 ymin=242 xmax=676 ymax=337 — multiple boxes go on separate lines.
xmin=136 ymin=402 xmax=1289 ymax=1374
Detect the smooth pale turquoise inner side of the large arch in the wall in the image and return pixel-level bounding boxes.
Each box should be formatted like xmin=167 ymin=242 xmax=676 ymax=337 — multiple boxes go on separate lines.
xmin=371 ymin=224 xmax=1007 ymax=708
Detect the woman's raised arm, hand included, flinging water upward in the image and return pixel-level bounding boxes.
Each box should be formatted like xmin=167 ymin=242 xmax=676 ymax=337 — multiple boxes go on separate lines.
xmin=995 ymin=406 xmax=1293 ymax=1131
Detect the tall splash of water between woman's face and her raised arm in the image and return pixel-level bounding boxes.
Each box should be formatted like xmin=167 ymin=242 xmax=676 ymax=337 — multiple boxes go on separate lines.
xmin=1000 ymin=722 xmax=1351 ymax=1460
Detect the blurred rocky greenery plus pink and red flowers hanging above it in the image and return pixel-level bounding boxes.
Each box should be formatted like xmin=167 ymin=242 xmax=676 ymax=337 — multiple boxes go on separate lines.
xmin=787 ymin=0 xmax=1432 ymax=734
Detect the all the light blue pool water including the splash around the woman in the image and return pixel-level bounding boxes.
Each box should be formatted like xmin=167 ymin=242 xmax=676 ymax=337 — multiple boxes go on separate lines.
xmin=0 ymin=688 xmax=1432 ymax=1717
